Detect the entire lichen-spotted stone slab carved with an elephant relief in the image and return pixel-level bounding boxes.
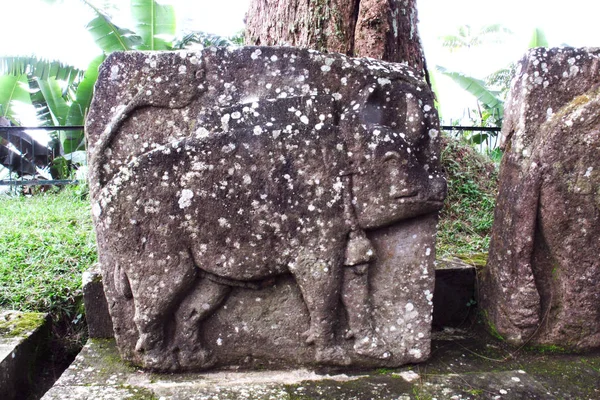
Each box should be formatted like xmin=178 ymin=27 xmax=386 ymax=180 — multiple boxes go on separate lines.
xmin=87 ymin=47 xmax=446 ymax=370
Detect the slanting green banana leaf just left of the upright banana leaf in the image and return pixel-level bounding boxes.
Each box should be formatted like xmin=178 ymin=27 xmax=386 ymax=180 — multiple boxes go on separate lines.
xmin=84 ymin=0 xmax=142 ymax=54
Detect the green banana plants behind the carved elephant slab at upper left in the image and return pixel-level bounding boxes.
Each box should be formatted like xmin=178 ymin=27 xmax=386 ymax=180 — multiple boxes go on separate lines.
xmin=0 ymin=0 xmax=243 ymax=180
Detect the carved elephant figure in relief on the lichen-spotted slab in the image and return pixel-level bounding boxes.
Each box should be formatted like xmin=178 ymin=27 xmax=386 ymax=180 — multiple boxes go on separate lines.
xmin=91 ymin=49 xmax=446 ymax=371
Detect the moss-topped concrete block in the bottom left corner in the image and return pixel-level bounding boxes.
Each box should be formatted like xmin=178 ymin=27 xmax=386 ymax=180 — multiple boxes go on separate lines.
xmin=0 ymin=310 xmax=50 ymax=400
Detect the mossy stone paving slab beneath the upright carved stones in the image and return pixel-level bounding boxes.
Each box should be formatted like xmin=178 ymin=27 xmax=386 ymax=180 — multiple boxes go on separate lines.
xmin=43 ymin=331 xmax=600 ymax=400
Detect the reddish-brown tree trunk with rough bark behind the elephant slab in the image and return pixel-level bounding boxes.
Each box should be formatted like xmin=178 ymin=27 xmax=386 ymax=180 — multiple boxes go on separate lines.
xmin=246 ymin=0 xmax=427 ymax=76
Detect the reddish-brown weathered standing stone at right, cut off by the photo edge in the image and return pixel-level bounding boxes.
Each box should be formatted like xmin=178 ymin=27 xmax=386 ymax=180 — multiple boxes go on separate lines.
xmin=481 ymin=48 xmax=600 ymax=349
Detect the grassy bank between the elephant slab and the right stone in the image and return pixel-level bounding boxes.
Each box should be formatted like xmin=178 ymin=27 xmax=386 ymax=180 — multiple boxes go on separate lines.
xmin=437 ymin=138 xmax=498 ymax=258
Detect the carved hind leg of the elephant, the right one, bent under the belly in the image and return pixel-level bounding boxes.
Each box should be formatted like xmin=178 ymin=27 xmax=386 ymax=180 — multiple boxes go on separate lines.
xmin=175 ymin=278 xmax=231 ymax=369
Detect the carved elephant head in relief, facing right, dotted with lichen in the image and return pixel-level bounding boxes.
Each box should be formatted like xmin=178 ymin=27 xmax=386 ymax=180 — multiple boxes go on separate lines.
xmin=346 ymin=83 xmax=446 ymax=229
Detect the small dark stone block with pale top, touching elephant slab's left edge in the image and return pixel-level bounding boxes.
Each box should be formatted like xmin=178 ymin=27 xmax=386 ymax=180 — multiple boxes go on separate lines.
xmin=82 ymin=264 xmax=114 ymax=338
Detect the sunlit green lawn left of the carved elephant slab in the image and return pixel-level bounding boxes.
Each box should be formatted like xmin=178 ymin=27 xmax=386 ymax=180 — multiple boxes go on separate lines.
xmin=0 ymin=187 xmax=96 ymax=319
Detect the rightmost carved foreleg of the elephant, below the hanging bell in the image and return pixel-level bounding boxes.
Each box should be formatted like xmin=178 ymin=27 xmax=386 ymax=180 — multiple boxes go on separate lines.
xmin=342 ymin=264 xmax=391 ymax=359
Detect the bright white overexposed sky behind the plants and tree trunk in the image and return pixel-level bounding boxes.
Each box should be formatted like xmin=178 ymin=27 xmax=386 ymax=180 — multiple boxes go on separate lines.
xmin=0 ymin=0 xmax=600 ymax=123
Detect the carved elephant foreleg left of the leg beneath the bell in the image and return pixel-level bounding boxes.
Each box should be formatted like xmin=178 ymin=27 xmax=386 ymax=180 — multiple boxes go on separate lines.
xmin=291 ymin=256 xmax=351 ymax=365
